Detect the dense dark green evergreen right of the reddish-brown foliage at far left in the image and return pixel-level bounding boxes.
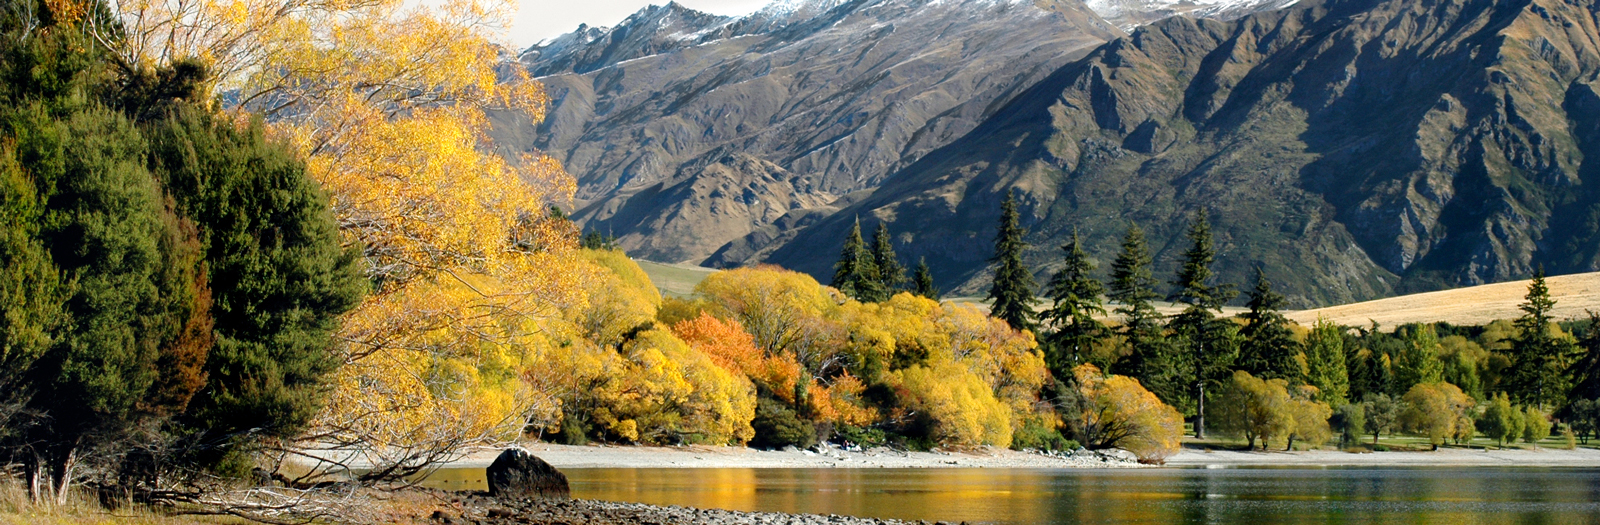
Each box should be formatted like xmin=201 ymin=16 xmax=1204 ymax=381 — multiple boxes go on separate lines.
xmin=149 ymin=109 xmax=366 ymax=451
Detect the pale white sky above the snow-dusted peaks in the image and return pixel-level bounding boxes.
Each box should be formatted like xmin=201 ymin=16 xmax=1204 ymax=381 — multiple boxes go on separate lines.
xmin=507 ymin=0 xmax=771 ymax=46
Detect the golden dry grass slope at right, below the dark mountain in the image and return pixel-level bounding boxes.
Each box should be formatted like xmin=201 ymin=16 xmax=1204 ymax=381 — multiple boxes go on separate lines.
xmin=1288 ymin=272 xmax=1600 ymax=327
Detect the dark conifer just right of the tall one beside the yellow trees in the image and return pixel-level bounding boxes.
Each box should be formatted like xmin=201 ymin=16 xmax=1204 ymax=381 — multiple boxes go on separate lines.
xmin=1040 ymin=230 xmax=1106 ymax=372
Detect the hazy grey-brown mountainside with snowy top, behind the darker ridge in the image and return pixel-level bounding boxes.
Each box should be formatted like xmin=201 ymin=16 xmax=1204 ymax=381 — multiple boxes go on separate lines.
xmin=512 ymin=0 xmax=1122 ymax=263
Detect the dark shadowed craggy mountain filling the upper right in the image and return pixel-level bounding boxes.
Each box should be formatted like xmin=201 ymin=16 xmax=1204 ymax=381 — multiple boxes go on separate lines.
xmin=758 ymin=0 xmax=1600 ymax=306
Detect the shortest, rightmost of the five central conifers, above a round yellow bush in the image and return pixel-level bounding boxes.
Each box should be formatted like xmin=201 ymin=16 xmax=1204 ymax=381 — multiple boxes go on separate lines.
xmin=1237 ymin=267 xmax=1306 ymax=384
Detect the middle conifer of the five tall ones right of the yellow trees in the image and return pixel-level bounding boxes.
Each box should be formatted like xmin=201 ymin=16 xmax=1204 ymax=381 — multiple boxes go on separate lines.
xmin=1106 ymin=224 xmax=1173 ymax=388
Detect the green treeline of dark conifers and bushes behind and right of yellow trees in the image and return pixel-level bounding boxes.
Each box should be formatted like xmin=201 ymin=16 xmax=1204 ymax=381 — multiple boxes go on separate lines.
xmin=834 ymin=190 xmax=1600 ymax=440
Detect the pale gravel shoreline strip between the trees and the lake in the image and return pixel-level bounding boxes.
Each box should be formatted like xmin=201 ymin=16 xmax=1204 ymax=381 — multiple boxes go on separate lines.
xmin=445 ymin=443 xmax=1600 ymax=469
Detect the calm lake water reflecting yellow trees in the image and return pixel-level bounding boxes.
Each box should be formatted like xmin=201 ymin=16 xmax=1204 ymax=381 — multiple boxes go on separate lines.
xmin=429 ymin=467 xmax=1600 ymax=525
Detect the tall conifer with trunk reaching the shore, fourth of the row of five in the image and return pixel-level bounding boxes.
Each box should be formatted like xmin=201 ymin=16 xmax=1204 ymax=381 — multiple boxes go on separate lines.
xmin=1166 ymin=210 xmax=1238 ymax=439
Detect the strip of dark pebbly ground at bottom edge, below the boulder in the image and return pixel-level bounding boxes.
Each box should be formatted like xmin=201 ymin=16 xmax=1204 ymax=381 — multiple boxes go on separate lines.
xmin=434 ymin=493 xmax=965 ymax=525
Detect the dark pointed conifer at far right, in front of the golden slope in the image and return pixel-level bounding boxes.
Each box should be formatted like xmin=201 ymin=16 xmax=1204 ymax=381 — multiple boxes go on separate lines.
xmin=1507 ymin=269 xmax=1571 ymax=410
